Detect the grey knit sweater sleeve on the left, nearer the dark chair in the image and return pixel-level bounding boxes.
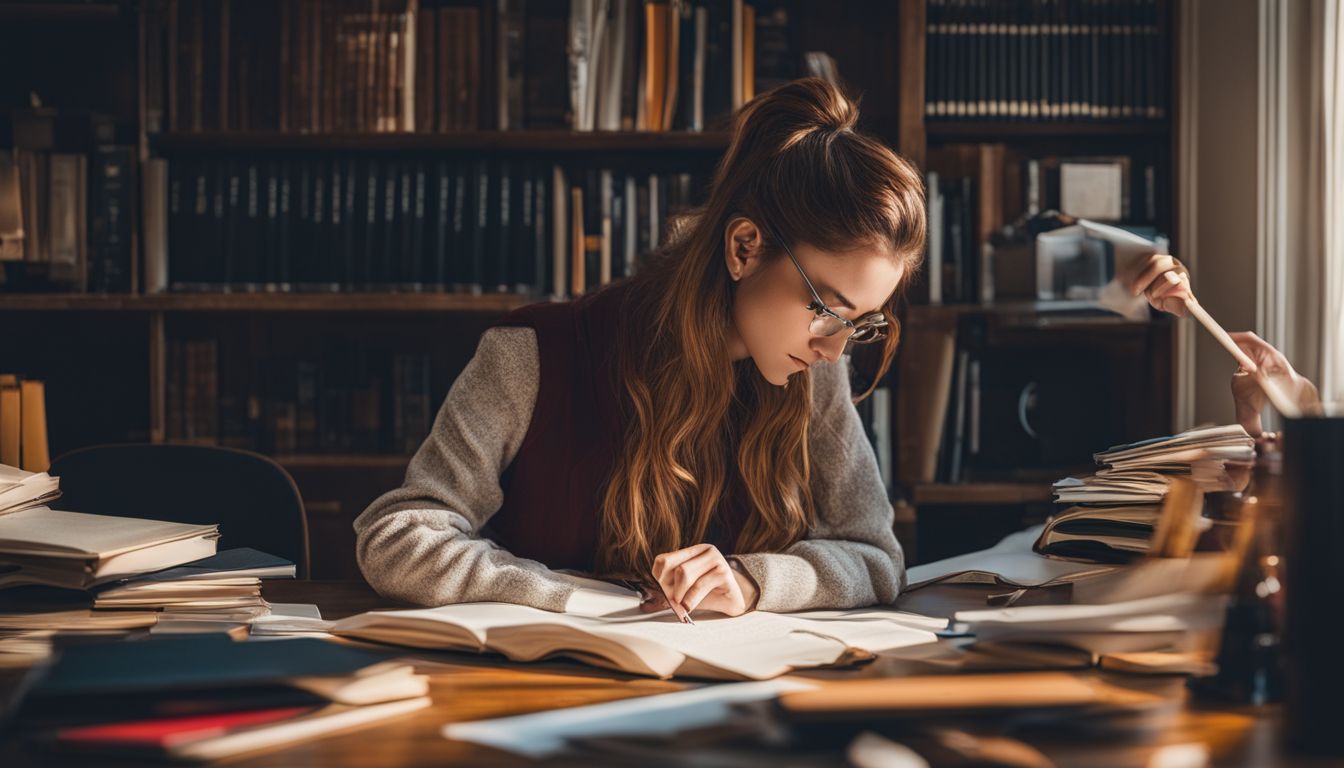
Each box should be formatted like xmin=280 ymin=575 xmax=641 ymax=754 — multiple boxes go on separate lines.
xmin=355 ymin=328 xmax=588 ymax=611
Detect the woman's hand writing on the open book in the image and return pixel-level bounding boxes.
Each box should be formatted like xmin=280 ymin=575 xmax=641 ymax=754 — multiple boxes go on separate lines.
xmin=640 ymin=543 xmax=759 ymax=616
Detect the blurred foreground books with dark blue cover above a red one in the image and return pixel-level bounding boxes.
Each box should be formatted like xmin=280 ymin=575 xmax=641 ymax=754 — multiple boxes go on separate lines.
xmin=17 ymin=635 xmax=430 ymax=761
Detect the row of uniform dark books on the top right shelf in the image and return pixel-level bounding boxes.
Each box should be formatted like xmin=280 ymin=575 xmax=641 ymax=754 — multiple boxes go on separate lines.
xmin=925 ymin=0 xmax=1171 ymax=121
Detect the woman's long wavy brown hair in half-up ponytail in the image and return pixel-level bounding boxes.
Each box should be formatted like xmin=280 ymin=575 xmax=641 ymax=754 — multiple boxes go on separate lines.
xmin=597 ymin=78 xmax=925 ymax=581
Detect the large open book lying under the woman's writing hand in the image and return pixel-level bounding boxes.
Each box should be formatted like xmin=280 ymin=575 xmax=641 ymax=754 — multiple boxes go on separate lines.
xmin=331 ymin=581 xmax=946 ymax=679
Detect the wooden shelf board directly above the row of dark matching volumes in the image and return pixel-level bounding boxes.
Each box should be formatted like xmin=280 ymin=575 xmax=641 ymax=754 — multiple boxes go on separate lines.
xmin=151 ymin=130 xmax=728 ymax=153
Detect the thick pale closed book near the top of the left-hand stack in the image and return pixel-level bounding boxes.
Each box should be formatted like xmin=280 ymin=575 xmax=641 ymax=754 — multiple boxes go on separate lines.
xmin=0 ymin=507 xmax=219 ymax=589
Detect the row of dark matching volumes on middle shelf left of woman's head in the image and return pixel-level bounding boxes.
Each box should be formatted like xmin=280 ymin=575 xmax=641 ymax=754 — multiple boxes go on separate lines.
xmin=154 ymin=155 xmax=700 ymax=297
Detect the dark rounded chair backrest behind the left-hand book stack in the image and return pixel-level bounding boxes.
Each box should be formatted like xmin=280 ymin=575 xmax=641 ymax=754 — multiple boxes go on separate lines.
xmin=48 ymin=444 xmax=309 ymax=578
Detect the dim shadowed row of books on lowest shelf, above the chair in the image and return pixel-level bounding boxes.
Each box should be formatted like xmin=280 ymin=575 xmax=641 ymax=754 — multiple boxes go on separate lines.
xmin=165 ymin=338 xmax=444 ymax=456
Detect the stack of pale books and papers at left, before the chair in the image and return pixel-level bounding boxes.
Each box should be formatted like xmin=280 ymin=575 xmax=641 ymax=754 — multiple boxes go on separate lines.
xmin=0 ymin=507 xmax=294 ymax=663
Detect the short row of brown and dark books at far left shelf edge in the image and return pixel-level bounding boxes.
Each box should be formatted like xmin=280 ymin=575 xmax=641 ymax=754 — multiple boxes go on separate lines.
xmin=0 ymin=145 xmax=137 ymax=292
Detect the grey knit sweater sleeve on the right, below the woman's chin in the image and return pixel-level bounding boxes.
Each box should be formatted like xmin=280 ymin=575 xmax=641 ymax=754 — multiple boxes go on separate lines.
xmin=734 ymin=358 xmax=906 ymax=612
